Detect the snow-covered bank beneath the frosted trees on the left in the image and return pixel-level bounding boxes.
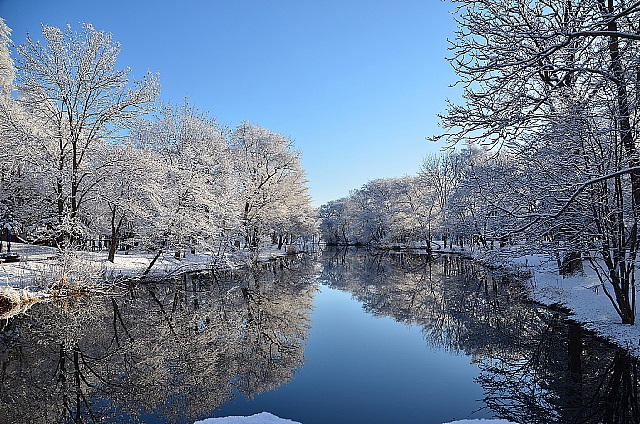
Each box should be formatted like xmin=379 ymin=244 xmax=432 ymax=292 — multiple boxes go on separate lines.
xmin=0 ymin=243 xmax=300 ymax=318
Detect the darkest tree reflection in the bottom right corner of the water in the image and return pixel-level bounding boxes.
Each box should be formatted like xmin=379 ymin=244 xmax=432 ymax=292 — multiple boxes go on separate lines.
xmin=479 ymin=315 xmax=640 ymax=423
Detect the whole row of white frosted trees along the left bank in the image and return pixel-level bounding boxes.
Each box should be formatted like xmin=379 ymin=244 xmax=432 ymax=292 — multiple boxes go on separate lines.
xmin=0 ymin=19 xmax=316 ymax=261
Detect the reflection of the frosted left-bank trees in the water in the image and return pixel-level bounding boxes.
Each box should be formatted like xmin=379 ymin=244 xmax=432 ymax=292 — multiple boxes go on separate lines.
xmin=0 ymin=255 xmax=315 ymax=423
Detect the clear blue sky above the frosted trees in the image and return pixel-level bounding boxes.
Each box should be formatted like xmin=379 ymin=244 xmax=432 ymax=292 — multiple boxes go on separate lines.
xmin=0 ymin=0 xmax=459 ymax=206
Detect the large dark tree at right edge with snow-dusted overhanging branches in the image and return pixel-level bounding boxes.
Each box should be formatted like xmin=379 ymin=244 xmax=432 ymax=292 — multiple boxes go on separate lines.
xmin=442 ymin=0 xmax=640 ymax=324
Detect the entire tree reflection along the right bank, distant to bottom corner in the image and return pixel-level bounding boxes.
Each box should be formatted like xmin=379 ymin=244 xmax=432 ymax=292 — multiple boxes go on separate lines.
xmin=321 ymin=250 xmax=640 ymax=423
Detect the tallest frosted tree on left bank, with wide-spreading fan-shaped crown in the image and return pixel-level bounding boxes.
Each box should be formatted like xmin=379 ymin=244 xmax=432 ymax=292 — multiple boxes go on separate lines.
xmin=16 ymin=24 xmax=159 ymax=245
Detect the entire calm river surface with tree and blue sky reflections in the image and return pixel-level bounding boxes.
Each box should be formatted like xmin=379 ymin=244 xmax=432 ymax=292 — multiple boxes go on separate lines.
xmin=0 ymin=250 xmax=640 ymax=424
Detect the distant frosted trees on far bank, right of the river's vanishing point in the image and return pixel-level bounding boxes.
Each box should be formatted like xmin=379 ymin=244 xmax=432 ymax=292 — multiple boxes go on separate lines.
xmin=320 ymin=149 xmax=472 ymax=251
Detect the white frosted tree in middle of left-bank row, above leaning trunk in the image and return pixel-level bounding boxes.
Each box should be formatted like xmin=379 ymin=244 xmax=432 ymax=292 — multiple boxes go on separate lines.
xmin=133 ymin=101 xmax=238 ymax=258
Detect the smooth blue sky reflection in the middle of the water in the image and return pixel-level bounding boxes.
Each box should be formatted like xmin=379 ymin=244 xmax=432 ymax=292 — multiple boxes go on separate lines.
xmin=216 ymin=287 xmax=489 ymax=424
